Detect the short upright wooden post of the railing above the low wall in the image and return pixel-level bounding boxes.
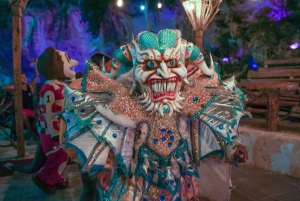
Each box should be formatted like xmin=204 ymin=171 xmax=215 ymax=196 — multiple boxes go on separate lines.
xmin=266 ymin=88 xmax=280 ymax=132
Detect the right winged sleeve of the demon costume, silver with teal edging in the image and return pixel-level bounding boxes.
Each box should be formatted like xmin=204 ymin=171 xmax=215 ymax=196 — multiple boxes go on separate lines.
xmin=184 ymin=64 xmax=250 ymax=162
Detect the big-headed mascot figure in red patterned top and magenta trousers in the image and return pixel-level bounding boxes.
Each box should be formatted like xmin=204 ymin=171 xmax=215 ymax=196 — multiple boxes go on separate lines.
xmin=32 ymin=47 xmax=78 ymax=193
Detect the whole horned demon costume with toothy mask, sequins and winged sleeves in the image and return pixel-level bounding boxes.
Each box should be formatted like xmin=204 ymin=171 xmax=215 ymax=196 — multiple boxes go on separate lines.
xmin=53 ymin=29 xmax=247 ymax=201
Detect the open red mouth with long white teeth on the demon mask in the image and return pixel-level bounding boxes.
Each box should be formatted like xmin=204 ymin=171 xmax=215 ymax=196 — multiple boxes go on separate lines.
xmin=148 ymin=76 xmax=178 ymax=101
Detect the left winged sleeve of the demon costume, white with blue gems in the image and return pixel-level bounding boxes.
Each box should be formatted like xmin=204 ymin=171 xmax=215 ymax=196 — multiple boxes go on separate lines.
xmin=53 ymin=60 xmax=138 ymax=176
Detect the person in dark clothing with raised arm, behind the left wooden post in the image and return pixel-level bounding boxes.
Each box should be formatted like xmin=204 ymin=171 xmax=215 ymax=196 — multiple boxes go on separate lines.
xmin=3 ymin=59 xmax=38 ymax=142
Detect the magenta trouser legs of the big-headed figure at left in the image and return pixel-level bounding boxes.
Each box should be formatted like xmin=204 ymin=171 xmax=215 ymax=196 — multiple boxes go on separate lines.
xmin=38 ymin=134 xmax=68 ymax=185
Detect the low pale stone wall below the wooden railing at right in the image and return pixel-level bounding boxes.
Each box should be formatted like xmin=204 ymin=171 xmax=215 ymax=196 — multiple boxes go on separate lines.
xmin=239 ymin=127 xmax=300 ymax=177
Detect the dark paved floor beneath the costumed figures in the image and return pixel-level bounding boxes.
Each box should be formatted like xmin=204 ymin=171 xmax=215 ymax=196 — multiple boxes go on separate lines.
xmin=0 ymin=136 xmax=300 ymax=201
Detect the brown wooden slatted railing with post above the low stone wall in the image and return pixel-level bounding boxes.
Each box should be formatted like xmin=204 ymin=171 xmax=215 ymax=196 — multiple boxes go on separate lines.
xmin=238 ymin=58 xmax=300 ymax=131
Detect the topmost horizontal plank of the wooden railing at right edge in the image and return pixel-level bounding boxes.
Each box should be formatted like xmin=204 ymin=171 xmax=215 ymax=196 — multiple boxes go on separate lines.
xmin=247 ymin=67 xmax=300 ymax=80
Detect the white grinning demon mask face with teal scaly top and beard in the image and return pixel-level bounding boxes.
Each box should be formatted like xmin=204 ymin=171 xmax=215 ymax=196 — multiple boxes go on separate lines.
xmin=130 ymin=29 xmax=187 ymax=116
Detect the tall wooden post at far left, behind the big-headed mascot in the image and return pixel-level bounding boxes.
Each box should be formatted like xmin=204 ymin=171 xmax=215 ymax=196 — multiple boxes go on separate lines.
xmin=10 ymin=0 xmax=28 ymax=158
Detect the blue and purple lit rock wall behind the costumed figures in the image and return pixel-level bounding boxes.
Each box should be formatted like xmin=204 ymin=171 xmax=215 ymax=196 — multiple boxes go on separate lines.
xmin=0 ymin=6 xmax=193 ymax=86
